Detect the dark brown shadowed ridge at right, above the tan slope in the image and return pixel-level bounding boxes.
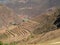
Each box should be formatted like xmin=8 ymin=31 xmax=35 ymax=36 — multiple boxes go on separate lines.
xmin=32 ymin=8 xmax=60 ymax=32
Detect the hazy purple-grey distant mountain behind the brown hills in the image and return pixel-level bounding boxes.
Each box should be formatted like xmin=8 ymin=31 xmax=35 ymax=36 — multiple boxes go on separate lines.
xmin=0 ymin=0 xmax=60 ymax=16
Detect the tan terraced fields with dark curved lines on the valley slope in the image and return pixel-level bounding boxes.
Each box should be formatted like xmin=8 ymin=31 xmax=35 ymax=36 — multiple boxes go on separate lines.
xmin=0 ymin=20 xmax=39 ymax=42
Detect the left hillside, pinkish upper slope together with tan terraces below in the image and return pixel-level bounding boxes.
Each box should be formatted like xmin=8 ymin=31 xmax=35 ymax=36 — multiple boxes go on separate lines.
xmin=0 ymin=5 xmax=39 ymax=43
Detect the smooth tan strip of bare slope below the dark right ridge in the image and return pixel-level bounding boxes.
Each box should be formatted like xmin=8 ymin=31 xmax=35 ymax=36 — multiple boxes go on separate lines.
xmin=28 ymin=29 xmax=60 ymax=44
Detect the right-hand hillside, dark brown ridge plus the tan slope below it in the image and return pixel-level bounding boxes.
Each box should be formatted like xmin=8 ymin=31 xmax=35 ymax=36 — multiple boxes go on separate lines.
xmin=28 ymin=7 xmax=60 ymax=44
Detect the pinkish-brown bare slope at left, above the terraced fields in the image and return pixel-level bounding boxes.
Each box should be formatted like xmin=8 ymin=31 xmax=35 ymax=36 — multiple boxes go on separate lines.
xmin=0 ymin=4 xmax=18 ymax=27
